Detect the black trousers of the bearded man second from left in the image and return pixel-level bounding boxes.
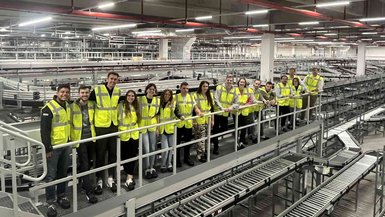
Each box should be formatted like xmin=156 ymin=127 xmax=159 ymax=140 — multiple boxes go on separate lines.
xmin=77 ymin=142 xmax=96 ymax=193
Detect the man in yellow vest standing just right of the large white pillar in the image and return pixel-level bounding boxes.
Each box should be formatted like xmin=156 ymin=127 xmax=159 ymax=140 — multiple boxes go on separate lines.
xmin=275 ymin=75 xmax=293 ymax=131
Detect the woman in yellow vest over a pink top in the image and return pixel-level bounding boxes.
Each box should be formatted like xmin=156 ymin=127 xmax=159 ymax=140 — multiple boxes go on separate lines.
xmin=233 ymin=78 xmax=257 ymax=149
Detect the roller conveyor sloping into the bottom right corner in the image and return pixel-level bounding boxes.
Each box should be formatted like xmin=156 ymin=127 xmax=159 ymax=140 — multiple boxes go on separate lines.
xmin=278 ymin=154 xmax=377 ymax=217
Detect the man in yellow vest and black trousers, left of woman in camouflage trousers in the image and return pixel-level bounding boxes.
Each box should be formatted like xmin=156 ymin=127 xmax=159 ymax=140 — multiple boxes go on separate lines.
xmin=175 ymin=82 xmax=201 ymax=167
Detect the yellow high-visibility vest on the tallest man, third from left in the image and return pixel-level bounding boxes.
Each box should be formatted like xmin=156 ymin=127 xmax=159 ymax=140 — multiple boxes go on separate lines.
xmin=95 ymin=85 xmax=121 ymax=128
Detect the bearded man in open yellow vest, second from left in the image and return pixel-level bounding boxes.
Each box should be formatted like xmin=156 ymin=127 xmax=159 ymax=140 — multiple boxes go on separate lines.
xmin=70 ymin=85 xmax=98 ymax=203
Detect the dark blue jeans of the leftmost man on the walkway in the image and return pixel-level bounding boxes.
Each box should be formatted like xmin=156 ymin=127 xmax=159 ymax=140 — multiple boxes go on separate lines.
xmin=45 ymin=147 xmax=71 ymax=204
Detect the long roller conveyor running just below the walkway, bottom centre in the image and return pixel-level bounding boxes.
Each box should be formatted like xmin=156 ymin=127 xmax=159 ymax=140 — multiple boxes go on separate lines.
xmin=149 ymin=153 xmax=309 ymax=217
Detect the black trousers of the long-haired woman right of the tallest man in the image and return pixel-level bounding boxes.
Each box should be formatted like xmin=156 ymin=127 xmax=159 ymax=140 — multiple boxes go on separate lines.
xmin=120 ymin=138 xmax=139 ymax=175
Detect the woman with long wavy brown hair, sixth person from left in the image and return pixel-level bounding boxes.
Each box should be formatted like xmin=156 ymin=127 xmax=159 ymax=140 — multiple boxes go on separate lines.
xmin=158 ymin=89 xmax=180 ymax=173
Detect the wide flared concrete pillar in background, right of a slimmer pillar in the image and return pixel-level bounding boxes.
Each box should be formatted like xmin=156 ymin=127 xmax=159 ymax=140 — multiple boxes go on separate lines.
xmin=171 ymin=37 xmax=196 ymax=60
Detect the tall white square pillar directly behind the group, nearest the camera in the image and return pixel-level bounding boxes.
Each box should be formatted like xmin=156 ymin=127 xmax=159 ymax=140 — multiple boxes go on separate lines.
xmin=261 ymin=33 xmax=274 ymax=81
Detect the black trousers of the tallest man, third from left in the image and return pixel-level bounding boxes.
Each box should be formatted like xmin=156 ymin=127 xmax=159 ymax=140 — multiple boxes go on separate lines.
xmin=95 ymin=125 xmax=118 ymax=179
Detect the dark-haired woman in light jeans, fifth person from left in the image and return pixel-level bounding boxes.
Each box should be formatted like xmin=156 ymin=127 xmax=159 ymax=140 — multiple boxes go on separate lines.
xmin=138 ymin=83 xmax=160 ymax=179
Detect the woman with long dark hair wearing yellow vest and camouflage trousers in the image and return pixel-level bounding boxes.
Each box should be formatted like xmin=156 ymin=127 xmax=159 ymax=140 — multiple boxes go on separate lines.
xmin=194 ymin=81 xmax=214 ymax=162
